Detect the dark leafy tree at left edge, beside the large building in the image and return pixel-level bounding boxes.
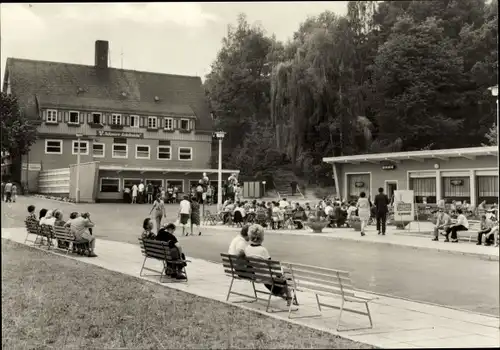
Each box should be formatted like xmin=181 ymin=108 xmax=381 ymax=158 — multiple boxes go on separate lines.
xmin=0 ymin=92 xmax=36 ymax=159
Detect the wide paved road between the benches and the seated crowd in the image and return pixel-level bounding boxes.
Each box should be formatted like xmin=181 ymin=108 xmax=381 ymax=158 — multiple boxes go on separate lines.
xmin=2 ymin=197 xmax=499 ymax=316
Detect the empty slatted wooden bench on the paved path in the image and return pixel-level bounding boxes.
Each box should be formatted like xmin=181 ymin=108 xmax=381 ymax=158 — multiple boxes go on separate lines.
xmin=283 ymin=263 xmax=377 ymax=331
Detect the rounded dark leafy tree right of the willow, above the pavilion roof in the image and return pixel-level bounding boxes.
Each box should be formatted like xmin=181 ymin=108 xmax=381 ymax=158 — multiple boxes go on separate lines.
xmin=372 ymin=16 xmax=464 ymax=150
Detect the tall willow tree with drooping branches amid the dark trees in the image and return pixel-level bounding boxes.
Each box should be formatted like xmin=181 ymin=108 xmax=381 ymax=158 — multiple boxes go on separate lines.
xmin=271 ymin=13 xmax=372 ymax=179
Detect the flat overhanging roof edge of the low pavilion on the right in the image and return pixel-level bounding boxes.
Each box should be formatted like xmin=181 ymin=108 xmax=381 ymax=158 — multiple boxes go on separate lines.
xmin=323 ymin=146 xmax=498 ymax=164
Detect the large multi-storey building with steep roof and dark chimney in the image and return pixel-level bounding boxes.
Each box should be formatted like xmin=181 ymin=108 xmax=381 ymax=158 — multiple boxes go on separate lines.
xmin=3 ymin=41 xmax=237 ymax=201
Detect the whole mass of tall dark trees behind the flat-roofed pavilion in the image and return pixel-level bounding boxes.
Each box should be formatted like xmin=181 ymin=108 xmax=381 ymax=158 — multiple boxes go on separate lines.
xmin=206 ymin=0 xmax=498 ymax=182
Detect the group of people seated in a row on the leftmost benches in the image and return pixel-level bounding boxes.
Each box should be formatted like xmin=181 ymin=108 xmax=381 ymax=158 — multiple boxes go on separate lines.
xmin=26 ymin=205 xmax=97 ymax=257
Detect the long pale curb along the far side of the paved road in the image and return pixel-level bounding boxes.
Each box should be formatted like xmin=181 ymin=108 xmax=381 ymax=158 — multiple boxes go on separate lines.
xmin=200 ymin=225 xmax=500 ymax=261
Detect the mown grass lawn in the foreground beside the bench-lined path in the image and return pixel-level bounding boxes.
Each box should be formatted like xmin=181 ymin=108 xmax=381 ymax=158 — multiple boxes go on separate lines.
xmin=2 ymin=239 xmax=373 ymax=349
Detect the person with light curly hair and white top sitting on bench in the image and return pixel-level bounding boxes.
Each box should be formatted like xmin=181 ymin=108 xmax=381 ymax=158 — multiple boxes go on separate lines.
xmin=245 ymin=224 xmax=297 ymax=305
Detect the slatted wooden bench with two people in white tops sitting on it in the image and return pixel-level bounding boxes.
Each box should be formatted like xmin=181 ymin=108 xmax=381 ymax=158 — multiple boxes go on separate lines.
xmin=221 ymin=253 xmax=297 ymax=312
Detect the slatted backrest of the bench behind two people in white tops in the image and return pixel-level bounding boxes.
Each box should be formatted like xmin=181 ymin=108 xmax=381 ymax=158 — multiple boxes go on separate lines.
xmin=221 ymin=253 xmax=283 ymax=286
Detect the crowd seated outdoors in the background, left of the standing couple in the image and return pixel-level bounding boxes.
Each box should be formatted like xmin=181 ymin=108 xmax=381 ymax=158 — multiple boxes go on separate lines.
xmin=220 ymin=198 xmax=357 ymax=230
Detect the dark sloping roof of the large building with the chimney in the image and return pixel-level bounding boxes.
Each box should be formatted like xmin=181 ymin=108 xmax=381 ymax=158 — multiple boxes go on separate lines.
xmin=4 ymin=57 xmax=213 ymax=131
